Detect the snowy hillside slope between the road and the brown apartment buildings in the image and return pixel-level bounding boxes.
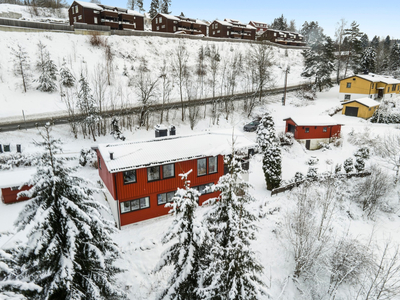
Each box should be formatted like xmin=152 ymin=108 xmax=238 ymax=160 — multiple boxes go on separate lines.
xmin=0 ymin=32 xmax=303 ymax=117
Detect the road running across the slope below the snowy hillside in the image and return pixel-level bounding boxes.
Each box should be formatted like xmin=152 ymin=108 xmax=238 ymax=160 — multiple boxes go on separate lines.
xmin=0 ymin=85 xmax=303 ymax=132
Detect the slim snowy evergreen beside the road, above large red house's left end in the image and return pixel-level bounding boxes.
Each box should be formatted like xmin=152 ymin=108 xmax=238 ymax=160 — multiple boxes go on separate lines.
xmin=77 ymin=74 xmax=101 ymax=141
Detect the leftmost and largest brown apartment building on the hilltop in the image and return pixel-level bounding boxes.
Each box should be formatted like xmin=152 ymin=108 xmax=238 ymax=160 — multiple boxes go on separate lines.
xmin=68 ymin=1 xmax=144 ymax=30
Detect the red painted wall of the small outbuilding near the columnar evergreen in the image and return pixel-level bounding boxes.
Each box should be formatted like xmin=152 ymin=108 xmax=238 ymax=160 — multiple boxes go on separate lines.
xmin=285 ymin=119 xmax=342 ymax=139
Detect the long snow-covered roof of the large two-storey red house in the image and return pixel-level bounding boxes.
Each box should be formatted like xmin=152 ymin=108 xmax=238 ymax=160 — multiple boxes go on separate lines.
xmin=98 ymin=132 xmax=255 ymax=173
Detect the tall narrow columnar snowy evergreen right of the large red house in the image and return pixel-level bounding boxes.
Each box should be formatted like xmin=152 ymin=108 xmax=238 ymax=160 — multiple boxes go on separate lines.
xmin=257 ymin=112 xmax=282 ymax=190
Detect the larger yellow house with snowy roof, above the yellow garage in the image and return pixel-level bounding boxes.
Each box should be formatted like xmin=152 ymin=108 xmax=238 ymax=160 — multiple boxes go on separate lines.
xmin=339 ymin=73 xmax=400 ymax=101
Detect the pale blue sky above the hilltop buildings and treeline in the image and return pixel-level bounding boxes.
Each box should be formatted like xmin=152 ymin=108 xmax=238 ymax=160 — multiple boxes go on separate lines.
xmin=68 ymin=0 xmax=400 ymax=40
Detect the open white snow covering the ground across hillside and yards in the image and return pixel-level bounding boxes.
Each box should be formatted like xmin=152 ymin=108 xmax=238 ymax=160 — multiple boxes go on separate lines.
xmin=0 ymin=22 xmax=400 ymax=300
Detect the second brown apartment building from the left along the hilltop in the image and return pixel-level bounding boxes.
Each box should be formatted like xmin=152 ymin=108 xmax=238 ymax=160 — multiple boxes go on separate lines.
xmin=151 ymin=13 xmax=208 ymax=36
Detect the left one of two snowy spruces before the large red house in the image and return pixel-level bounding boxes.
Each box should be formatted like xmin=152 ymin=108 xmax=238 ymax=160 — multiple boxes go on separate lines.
xmin=156 ymin=170 xmax=209 ymax=300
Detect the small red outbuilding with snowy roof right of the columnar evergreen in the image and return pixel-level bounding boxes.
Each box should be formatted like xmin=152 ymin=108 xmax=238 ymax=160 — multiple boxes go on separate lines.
xmin=284 ymin=116 xmax=342 ymax=150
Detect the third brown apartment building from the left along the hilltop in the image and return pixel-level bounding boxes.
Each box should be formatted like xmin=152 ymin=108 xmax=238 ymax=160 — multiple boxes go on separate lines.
xmin=209 ymin=19 xmax=256 ymax=41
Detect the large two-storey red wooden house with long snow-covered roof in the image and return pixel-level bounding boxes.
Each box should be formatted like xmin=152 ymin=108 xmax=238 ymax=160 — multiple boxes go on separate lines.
xmin=95 ymin=132 xmax=254 ymax=226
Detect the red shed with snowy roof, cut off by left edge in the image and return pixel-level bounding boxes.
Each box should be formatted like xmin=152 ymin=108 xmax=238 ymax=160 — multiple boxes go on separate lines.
xmin=0 ymin=169 xmax=36 ymax=204
